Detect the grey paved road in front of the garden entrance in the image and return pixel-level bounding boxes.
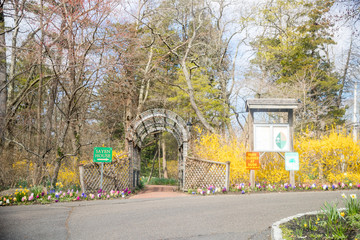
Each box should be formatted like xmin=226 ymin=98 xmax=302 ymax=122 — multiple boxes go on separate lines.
xmin=0 ymin=191 xmax=360 ymax=239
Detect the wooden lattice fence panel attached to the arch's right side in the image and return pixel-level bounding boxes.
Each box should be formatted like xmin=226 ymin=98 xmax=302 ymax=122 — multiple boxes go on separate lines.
xmin=184 ymin=157 xmax=229 ymax=189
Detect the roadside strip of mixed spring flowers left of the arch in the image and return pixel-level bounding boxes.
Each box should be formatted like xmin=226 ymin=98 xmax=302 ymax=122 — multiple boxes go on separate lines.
xmin=0 ymin=183 xmax=131 ymax=206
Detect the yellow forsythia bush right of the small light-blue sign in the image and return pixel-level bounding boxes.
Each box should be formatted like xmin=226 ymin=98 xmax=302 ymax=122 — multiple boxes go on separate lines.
xmin=294 ymin=128 xmax=360 ymax=183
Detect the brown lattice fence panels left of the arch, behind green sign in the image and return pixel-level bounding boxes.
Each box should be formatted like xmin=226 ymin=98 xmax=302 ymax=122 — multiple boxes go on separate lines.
xmin=83 ymin=158 xmax=130 ymax=192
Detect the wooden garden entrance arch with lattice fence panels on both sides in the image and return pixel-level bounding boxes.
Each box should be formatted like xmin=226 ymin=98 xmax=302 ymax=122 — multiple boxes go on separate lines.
xmin=79 ymin=109 xmax=230 ymax=192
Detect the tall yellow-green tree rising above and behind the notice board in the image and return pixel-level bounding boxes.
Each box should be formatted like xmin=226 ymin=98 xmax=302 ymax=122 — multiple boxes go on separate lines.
xmin=252 ymin=0 xmax=345 ymax=129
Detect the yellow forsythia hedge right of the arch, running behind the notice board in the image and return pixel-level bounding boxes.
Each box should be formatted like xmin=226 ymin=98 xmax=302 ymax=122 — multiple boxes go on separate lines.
xmin=194 ymin=126 xmax=360 ymax=184
